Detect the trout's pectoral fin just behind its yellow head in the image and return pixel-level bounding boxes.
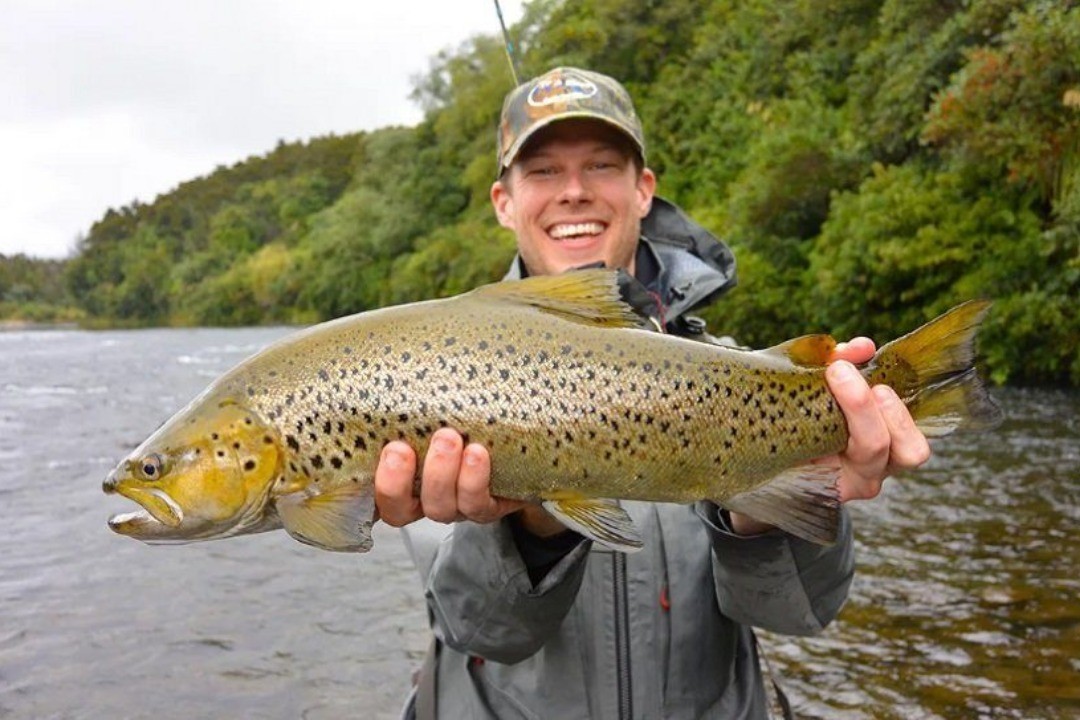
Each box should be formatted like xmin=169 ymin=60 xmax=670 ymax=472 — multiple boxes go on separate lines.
xmin=276 ymin=484 xmax=375 ymax=553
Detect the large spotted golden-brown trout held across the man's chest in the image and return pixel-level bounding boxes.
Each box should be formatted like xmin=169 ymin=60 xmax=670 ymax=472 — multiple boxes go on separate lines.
xmin=104 ymin=270 xmax=1000 ymax=552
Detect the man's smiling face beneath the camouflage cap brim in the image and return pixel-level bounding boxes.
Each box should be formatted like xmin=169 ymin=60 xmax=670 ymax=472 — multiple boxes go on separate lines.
xmin=491 ymin=119 xmax=657 ymax=275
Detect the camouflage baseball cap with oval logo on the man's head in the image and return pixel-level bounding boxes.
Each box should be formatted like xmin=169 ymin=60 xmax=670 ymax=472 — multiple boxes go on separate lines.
xmin=496 ymin=67 xmax=645 ymax=175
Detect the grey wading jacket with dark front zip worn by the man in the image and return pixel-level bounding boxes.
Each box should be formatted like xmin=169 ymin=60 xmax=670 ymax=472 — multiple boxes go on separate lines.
xmin=405 ymin=198 xmax=853 ymax=720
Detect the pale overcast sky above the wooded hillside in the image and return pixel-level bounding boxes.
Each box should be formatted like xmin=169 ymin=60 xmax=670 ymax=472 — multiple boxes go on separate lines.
xmin=0 ymin=0 xmax=523 ymax=257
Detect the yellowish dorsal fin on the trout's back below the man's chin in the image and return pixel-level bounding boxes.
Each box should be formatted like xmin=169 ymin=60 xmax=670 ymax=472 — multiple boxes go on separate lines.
xmin=470 ymin=269 xmax=648 ymax=327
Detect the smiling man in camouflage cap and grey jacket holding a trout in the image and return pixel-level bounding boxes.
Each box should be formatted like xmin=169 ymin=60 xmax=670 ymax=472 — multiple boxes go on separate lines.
xmin=376 ymin=68 xmax=929 ymax=720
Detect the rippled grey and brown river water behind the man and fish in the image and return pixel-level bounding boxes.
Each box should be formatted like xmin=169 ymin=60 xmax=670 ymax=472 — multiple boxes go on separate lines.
xmin=0 ymin=328 xmax=1080 ymax=720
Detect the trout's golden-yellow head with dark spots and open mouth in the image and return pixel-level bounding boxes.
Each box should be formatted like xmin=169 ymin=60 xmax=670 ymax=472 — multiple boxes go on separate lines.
xmin=103 ymin=399 xmax=283 ymax=543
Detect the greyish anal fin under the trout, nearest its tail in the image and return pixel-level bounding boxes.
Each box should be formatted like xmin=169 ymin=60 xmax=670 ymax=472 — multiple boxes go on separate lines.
xmin=717 ymin=464 xmax=840 ymax=545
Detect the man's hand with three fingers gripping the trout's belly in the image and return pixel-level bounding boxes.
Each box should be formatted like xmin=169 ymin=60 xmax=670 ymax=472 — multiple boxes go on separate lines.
xmin=375 ymin=427 xmax=531 ymax=528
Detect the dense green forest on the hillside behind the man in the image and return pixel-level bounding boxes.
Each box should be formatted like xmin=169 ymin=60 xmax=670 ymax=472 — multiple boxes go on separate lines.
xmin=0 ymin=0 xmax=1080 ymax=385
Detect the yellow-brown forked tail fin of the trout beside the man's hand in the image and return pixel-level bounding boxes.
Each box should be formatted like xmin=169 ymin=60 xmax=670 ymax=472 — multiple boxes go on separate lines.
xmin=863 ymin=300 xmax=1003 ymax=437
